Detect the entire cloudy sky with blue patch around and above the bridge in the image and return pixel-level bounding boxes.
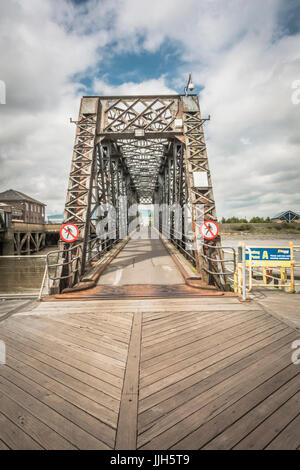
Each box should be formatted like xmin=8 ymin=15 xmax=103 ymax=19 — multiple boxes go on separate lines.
xmin=0 ymin=0 xmax=300 ymax=217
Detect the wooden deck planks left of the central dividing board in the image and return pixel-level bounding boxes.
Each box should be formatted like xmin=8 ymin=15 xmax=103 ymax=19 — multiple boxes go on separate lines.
xmin=0 ymin=302 xmax=132 ymax=449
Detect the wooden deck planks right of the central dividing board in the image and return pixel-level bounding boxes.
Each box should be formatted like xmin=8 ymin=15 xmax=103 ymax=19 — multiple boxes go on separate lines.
xmin=138 ymin=300 xmax=300 ymax=449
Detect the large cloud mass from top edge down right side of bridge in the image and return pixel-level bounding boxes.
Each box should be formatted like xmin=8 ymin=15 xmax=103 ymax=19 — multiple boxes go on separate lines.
xmin=101 ymin=0 xmax=300 ymax=216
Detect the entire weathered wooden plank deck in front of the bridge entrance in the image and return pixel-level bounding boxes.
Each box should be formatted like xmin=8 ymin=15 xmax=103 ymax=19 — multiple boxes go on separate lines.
xmin=0 ymin=297 xmax=300 ymax=450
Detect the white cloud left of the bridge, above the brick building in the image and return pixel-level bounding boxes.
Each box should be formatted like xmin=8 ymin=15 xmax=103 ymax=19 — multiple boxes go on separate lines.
xmin=0 ymin=0 xmax=103 ymax=212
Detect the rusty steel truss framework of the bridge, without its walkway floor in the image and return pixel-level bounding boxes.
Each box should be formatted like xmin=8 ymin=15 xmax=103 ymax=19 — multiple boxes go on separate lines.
xmin=52 ymin=94 xmax=230 ymax=292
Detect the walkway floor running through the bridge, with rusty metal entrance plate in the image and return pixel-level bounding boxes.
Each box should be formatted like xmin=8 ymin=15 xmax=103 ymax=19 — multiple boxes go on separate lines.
xmin=49 ymin=235 xmax=225 ymax=300
